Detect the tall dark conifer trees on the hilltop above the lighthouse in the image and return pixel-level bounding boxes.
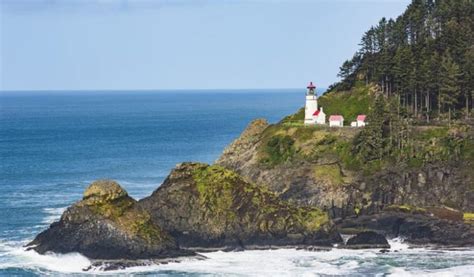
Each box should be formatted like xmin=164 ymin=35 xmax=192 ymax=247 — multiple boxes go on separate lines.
xmin=330 ymin=0 xmax=474 ymax=121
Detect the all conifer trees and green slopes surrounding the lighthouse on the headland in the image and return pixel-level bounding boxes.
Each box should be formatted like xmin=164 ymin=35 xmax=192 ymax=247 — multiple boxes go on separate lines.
xmin=250 ymin=0 xmax=474 ymax=181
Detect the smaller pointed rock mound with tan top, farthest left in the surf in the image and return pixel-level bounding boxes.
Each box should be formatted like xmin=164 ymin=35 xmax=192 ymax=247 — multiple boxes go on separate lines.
xmin=28 ymin=180 xmax=192 ymax=260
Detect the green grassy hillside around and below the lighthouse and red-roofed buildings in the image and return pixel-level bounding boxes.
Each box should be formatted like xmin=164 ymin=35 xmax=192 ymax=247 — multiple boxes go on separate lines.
xmin=258 ymin=83 xmax=474 ymax=176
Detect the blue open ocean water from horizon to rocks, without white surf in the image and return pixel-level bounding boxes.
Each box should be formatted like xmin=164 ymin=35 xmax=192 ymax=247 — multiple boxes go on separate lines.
xmin=0 ymin=90 xmax=304 ymax=272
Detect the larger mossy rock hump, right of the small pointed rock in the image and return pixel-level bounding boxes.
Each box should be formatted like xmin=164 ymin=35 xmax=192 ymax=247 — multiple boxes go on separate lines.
xmin=139 ymin=163 xmax=341 ymax=250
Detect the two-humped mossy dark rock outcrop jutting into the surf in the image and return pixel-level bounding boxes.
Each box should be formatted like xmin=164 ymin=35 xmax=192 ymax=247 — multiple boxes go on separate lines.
xmin=27 ymin=166 xmax=341 ymax=260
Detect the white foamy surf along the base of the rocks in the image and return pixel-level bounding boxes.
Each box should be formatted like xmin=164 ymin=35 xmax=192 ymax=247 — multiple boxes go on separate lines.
xmin=0 ymin=236 xmax=474 ymax=276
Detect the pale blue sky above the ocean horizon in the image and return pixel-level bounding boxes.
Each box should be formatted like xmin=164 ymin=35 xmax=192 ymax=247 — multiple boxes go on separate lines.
xmin=0 ymin=0 xmax=409 ymax=90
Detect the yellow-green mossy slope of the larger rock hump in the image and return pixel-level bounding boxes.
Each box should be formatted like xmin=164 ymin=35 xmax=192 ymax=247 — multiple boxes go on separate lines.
xmin=192 ymin=164 xmax=329 ymax=235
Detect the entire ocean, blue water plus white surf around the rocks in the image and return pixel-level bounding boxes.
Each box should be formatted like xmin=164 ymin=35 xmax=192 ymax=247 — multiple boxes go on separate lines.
xmin=0 ymin=89 xmax=474 ymax=276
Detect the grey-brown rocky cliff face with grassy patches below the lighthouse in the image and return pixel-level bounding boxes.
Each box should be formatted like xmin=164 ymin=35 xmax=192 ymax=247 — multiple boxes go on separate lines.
xmin=216 ymin=119 xmax=474 ymax=217
